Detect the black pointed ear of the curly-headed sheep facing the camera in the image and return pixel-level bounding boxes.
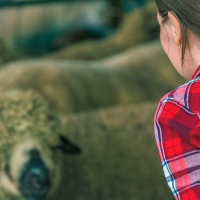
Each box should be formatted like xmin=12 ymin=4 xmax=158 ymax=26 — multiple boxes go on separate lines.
xmin=57 ymin=135 xmax=81 ymax=154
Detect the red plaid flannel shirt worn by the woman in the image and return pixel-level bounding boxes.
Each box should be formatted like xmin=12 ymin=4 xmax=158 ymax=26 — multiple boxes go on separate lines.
xmin=154 ymin=66 xmax=200 ymax=200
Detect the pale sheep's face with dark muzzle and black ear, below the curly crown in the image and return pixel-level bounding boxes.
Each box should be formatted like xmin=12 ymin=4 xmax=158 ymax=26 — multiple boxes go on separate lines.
xmin=0 ymin=134 xmax=79 ymax=200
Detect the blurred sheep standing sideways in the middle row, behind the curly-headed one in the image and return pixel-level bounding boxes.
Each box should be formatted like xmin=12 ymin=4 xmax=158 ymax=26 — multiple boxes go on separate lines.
xmin=0 ymin=41 xmax=183 ymax=113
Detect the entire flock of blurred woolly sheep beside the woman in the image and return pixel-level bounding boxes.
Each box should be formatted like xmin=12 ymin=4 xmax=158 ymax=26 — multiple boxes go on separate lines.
xmin=0 ymin=3 xmax=184 ymax=200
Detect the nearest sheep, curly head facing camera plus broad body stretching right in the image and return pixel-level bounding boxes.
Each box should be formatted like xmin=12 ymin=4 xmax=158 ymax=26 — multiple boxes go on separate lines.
xmin=0 ymin=90 xmax=172 ymax=200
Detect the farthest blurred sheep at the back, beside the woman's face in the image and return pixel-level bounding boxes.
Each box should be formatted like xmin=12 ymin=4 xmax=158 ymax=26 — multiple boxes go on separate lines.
xmin=44 ymin=2 xmax=159 ymax=60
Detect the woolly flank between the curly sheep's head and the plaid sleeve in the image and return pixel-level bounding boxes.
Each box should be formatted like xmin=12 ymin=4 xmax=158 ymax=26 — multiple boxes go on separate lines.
xmin=46 ymin=102 xmax=174 ymax=200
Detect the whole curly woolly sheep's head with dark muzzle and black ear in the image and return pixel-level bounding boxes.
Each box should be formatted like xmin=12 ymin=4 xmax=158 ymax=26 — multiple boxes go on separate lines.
xmin=0 ymin=90 xmax=80 ymax=200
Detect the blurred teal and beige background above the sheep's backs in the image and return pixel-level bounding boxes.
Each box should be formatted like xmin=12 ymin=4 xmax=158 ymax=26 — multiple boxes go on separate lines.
xmin=0 ymin=0 xmax=153 ymax=55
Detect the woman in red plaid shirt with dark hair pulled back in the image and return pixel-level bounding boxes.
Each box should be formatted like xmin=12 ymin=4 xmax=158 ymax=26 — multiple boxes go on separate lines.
xmin=154 ymin=0 xmax=200 ymax=200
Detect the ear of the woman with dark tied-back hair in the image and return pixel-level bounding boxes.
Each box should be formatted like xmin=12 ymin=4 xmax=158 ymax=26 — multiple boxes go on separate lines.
xmin=168 ymin=12 xmax=182 ymax=46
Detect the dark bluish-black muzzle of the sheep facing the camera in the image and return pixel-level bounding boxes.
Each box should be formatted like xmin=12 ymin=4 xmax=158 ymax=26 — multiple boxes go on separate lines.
xmin=19 ymin=150 xmax=50 ymax=200
